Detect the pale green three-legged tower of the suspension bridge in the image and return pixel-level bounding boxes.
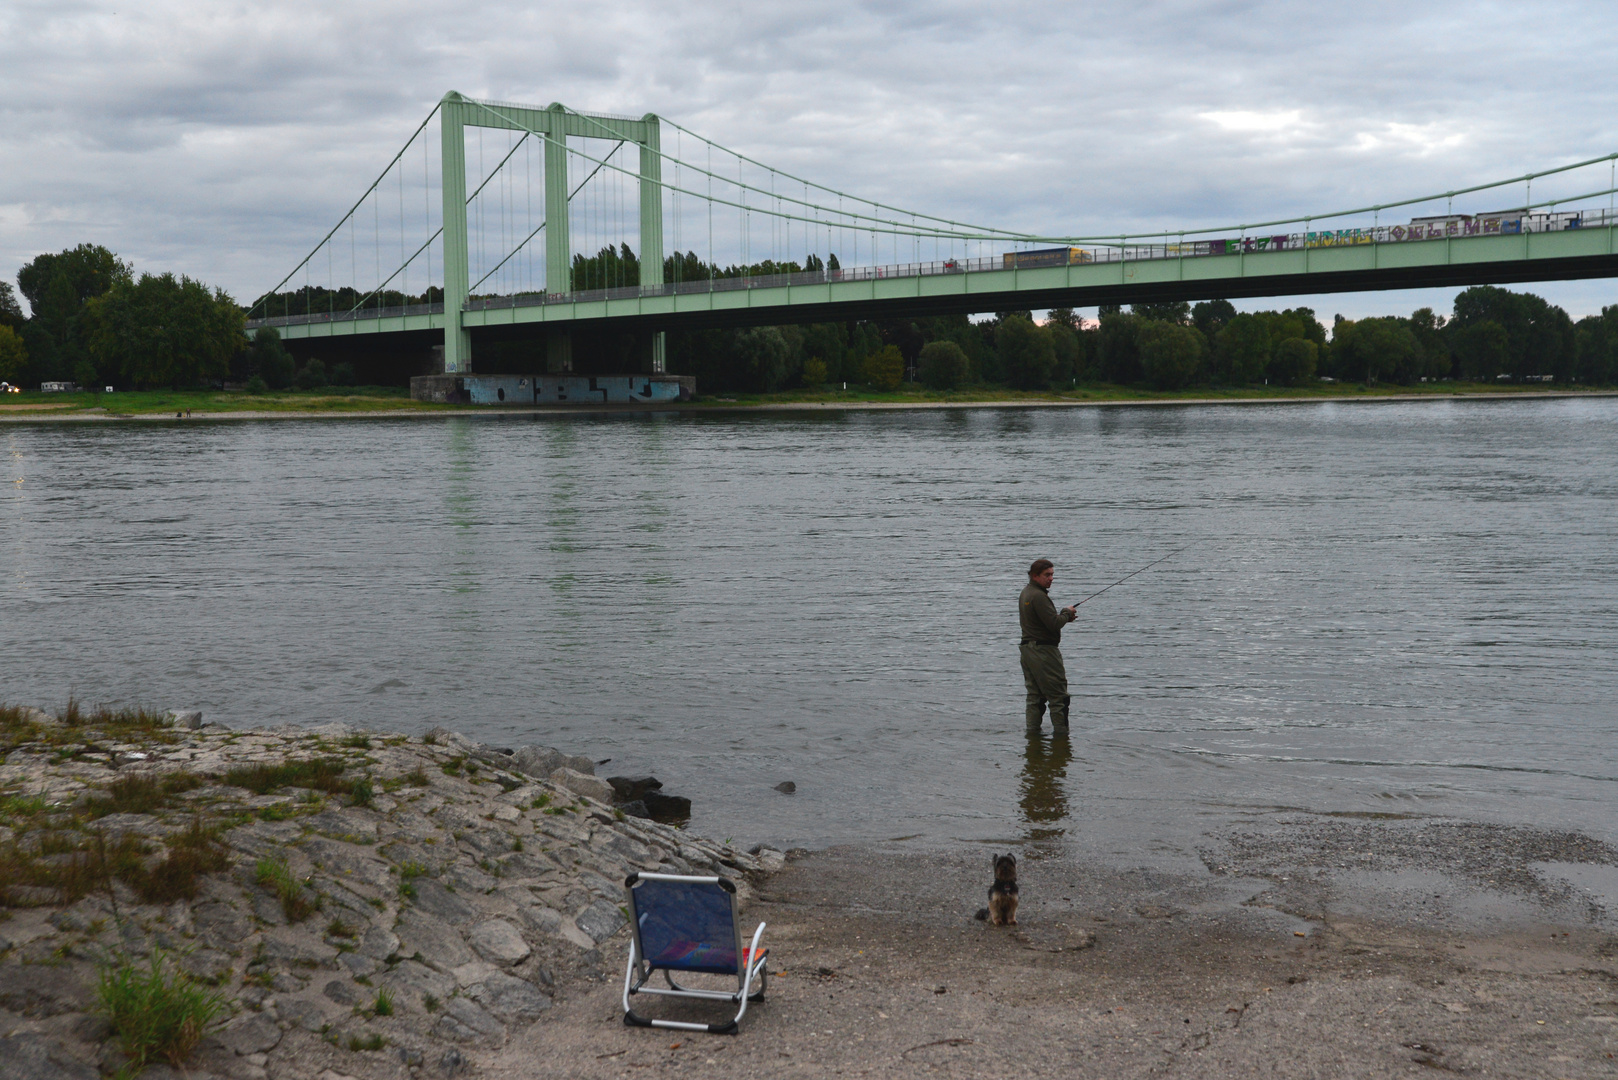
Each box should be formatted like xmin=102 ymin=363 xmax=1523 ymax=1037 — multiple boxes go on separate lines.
xmin=438 ymin=91 xmax=665 ymax=374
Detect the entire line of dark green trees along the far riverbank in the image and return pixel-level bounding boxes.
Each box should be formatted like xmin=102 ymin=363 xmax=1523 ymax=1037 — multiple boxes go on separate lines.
xmin=0 ymin=244 xmax=1618 ymax=393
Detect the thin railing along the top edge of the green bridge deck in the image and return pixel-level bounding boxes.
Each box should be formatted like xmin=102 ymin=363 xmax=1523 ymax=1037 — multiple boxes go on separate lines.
xmin=248 ymin=209 xmax=1618 ymax=329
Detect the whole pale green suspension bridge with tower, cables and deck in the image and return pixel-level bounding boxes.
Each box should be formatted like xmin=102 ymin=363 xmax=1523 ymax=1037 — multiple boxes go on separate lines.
xmin=248 ymin=92 xmax=1618 ymax=388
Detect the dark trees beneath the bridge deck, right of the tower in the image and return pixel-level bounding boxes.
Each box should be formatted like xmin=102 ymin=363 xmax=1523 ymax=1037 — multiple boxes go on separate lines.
xmin=668 ymin=285 xmax=1618 ymax=392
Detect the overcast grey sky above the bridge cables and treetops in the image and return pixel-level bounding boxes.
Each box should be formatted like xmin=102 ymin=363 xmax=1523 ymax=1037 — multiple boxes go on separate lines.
xmin=0 ymin=0 xmax=1618 ymax=322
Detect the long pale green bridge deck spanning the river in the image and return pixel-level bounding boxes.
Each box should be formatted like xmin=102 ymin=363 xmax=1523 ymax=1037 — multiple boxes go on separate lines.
xmin=248 ymin=223 xmax=1618 ymax=338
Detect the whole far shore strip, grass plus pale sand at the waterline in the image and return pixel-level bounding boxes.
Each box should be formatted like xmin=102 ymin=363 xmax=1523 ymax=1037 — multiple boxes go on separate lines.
xmin=0 ymin=385 xmax=1618 ymax=423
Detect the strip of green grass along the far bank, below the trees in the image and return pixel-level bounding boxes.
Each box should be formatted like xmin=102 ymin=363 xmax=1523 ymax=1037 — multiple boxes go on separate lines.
xmin=0 ymin=382 xmax=1612 ymax=419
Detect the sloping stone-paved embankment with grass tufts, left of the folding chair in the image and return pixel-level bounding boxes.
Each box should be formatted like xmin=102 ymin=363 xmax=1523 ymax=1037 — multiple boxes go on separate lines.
xmin=0 ymin=706 xmax=786 ymax=1080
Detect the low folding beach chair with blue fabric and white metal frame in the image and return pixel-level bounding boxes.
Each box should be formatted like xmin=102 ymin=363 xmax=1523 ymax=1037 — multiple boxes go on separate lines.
xmin=623 ymin=873 xmax=769 ymax=1035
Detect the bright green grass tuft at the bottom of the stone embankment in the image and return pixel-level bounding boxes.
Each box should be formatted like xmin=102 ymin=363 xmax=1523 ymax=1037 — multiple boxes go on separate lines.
xmin=95 ymin=949 xmax=230 ymax=1075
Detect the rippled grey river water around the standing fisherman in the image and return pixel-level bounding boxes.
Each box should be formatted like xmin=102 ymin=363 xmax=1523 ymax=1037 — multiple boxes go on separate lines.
xmin=0 ymin=398 xmax=1618 ymax=863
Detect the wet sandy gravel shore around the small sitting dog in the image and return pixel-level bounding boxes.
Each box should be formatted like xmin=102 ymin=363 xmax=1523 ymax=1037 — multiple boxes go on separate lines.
xmin=498 ymin=814 xmax=1618 ymax=1080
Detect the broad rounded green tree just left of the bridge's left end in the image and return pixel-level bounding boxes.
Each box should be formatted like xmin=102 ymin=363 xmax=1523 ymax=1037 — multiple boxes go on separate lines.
xmin=84 ymin=274 xmax=244 ymax=387
